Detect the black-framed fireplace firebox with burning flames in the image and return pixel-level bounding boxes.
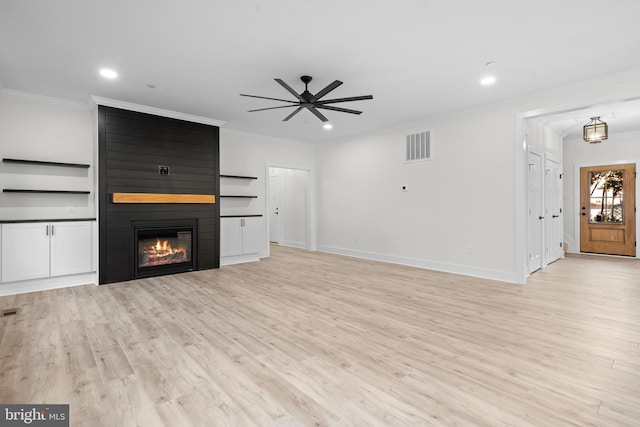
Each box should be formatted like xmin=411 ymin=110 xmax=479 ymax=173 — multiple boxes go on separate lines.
xmin=131 ymin=220 xmax=198 ymax=279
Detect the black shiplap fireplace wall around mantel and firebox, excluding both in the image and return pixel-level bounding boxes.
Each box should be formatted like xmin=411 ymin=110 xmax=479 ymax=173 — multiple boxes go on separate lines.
xmin=98 ymin=106 xmax=220 ymax=284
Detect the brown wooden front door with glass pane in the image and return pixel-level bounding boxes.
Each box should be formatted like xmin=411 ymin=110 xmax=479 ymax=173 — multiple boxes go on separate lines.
xmin=580 ymin=164 xmax=636 ymax=256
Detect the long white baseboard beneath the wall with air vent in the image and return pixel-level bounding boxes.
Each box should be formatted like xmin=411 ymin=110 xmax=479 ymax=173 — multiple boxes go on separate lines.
xmin=318 ymin=245 xmax=525 ymax=285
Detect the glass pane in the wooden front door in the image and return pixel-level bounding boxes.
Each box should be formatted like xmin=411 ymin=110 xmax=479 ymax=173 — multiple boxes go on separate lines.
xmin=589 ymin=170 xmax=624 ymax=224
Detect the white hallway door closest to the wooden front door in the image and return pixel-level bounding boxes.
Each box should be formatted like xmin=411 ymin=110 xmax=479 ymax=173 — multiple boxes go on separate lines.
xmin=543 ymin=156 xmax=564 ymax=265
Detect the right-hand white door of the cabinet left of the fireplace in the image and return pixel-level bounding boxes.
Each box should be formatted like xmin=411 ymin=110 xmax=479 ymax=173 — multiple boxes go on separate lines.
xmin=50 ymin=221 xmax=93 ymax=276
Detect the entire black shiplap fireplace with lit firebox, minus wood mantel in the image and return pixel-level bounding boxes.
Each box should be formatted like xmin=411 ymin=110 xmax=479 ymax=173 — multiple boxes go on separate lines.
xmin=98 ymin=105 xmax=220 ymax=284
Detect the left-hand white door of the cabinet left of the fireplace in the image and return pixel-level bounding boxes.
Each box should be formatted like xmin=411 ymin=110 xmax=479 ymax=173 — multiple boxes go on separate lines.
xmin=1 ymin=222 xmax=50 ymax=282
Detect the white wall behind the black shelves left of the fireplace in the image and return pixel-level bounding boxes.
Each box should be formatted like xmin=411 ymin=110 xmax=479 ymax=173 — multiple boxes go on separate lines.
xmin=0 ymin=90 xmax=96 ymax=220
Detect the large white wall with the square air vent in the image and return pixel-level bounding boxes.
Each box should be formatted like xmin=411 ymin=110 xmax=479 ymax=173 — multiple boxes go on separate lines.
xmin=317 ymin=72 xmax=640 ymax=283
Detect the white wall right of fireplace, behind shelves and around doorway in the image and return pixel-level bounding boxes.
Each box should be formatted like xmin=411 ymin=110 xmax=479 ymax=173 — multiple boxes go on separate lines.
xmin=220 ymin=128 xmax=315 ymax=255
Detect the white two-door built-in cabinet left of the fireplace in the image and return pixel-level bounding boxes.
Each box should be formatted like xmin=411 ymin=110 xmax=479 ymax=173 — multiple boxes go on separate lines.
xmin=0 ymin=221 xmax=94 ymax=283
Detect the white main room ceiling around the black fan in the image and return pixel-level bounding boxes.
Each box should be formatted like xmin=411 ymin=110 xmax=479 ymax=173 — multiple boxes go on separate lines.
xmin=0 ymin=0 xmax=640 ymax=142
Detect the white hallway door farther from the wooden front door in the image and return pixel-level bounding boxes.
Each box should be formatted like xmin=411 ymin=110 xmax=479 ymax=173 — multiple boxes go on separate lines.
xmin=527 ymin=152 xmax=544 ymax=273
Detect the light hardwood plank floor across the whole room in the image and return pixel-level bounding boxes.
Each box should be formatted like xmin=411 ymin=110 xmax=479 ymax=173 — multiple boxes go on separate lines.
xmin=0 ymin=247 xmax=640 ymax=427
